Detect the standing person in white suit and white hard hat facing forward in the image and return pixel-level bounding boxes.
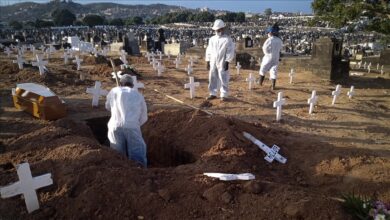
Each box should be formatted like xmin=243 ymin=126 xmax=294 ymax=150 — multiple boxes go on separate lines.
xmin=206 ymin=19 xmax=235 ymax=101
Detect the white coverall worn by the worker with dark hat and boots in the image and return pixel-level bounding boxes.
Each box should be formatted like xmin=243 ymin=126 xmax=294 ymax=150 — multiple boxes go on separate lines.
xmin=259 ymin=36 xmax=283 ymax=79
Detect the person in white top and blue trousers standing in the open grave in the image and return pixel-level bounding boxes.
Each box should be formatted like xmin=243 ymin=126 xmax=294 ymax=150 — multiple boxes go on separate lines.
xmin=106 ymin=74 xmax=148 ymax=167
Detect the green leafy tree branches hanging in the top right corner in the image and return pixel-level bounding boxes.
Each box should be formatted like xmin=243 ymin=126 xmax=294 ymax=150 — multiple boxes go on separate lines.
xmin=312 ymin=0 xmax=390 ymax=35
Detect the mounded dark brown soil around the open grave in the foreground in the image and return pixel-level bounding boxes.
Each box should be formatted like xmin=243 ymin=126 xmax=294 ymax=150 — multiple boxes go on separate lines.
xmin=0 ymin=109 xmax=389 ymax=219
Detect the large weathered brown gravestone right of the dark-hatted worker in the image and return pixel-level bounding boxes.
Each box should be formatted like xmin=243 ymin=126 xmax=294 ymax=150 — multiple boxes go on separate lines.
xmin=311 ymin=37 xmax=349 ymax=81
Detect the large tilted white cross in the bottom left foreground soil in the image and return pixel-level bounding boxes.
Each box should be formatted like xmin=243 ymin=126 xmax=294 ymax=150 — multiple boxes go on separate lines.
xmin=0 ymin=163 xmax=53 ymax=213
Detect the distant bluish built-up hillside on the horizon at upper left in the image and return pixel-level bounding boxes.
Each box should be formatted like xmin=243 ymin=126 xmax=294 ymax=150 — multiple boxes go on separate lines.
xmin=0 ymin=1 xmax=189 ymax=22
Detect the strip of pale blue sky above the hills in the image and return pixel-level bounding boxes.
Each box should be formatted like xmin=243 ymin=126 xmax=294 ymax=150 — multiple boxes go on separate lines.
xmin=0 ymin=0 xmax=313 ymax=13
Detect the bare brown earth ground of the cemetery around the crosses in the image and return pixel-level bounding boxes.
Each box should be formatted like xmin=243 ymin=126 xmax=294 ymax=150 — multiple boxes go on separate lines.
xmin=0 ymin=50 xmax=390 ymax=219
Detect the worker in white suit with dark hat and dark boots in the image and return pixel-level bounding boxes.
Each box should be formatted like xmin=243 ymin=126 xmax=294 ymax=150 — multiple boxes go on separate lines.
xmin=259 ymin=26 xmax=283 ymax=90
